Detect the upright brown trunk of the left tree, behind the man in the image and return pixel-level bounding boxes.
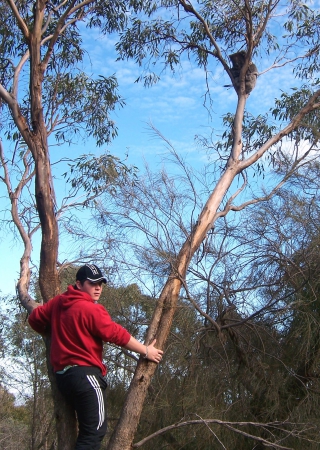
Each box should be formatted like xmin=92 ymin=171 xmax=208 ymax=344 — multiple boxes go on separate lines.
xmin=7 ymin=9 xmax=76 ymax=450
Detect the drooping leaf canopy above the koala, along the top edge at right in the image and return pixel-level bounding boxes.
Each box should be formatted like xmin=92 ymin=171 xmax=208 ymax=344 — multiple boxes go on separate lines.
xmin=116 ymin=0 xmax=310 ymax=89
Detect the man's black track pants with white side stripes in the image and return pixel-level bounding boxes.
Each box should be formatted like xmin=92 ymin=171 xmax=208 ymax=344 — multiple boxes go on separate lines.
xmin=56 ymin=366 xmax=107 ymax=450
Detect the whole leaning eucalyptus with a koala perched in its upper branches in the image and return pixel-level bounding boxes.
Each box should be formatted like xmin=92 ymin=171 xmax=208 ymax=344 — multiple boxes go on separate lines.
xmin=101 ymin=0 xmax=320 ymax=449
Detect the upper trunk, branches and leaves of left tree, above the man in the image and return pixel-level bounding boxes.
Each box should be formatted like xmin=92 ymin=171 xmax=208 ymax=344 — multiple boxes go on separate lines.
xmin=0 ymin=1 xmax=129 ymax=307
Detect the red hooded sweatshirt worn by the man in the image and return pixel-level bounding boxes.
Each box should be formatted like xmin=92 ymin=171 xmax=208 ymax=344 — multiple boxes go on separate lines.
xmin=28 ymin=286 xmax=131 ymax=375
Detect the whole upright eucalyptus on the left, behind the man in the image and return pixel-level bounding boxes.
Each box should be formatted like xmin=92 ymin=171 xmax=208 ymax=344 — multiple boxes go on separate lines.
xmin=0 ymin=0 xmax=136 ymax=449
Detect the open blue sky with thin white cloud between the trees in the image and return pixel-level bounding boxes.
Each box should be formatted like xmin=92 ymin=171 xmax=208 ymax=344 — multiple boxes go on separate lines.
xmin=0 ymin=6 xmax=316 ymax=295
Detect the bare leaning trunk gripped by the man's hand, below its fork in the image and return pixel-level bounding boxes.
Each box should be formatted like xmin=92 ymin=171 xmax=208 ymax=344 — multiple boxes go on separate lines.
xmin=108 ymin=146 xmax=241 ymax=450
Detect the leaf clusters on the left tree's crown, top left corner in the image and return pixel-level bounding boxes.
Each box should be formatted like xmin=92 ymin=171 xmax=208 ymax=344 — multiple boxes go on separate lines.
xmin=0 ymin=0 xmax=127 ymax=145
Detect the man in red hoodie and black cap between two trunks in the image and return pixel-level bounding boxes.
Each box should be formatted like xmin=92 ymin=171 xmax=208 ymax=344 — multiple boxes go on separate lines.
xmin=29 ymin=264 xmax=163 ymax=450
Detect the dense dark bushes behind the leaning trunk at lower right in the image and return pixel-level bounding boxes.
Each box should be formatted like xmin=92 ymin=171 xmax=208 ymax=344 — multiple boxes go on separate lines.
xmin=4 ymin=185 xmax=320 ymax=450
